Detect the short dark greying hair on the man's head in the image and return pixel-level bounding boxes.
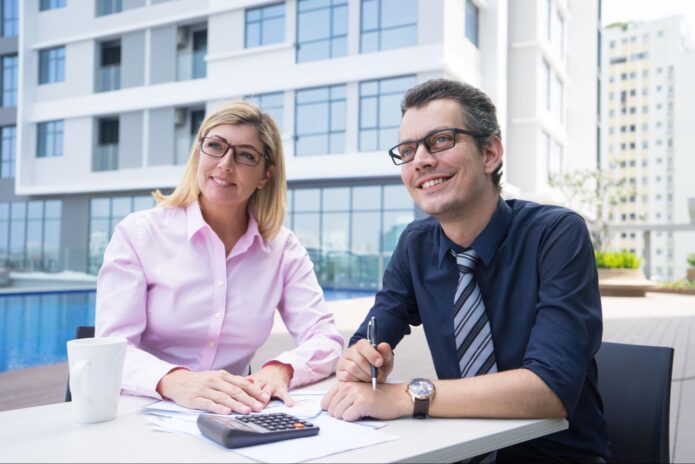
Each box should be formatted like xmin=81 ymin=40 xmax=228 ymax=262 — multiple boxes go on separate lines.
xmin=401 ymin=79 xmax=502 ymax=191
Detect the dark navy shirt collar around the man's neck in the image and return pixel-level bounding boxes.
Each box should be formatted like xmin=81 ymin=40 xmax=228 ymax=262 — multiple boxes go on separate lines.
xmin=438 ymin=197 xmax=512 ymax=266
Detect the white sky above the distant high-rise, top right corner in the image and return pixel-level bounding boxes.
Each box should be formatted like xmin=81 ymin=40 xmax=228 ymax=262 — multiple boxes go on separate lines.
xmin=603 ymin=0 xmax=695 ymax=29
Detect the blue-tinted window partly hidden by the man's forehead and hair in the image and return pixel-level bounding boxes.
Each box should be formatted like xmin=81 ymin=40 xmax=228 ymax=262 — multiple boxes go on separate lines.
xmin=359 ymin=76 xmax=415 ymax=151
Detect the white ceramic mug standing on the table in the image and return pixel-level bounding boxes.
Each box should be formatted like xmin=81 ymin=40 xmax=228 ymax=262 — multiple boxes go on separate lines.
xmin=68 ymin=337 xmax=127 ymax=423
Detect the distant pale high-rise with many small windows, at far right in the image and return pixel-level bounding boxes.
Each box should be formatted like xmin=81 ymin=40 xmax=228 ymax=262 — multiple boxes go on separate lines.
xmin=602 ymin=17 xmax=695 ymax=280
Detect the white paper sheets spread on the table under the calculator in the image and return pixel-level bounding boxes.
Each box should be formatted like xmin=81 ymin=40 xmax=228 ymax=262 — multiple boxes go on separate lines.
xmin=144 ymin=391 xmax=398 ymax=462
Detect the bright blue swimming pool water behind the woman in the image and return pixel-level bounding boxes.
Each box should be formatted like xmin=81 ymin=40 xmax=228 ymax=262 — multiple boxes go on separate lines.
xmin=0 ymin=290 xmax=375 ymax=372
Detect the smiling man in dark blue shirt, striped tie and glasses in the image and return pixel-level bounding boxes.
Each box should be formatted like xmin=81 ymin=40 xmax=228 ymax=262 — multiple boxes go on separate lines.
xmin=322 ymin=79 xmax=609 ymax=462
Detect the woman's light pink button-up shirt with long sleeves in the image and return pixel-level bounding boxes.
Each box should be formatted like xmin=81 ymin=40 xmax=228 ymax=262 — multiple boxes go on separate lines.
xmin=96 ymin=203 xmax=344 ymax=398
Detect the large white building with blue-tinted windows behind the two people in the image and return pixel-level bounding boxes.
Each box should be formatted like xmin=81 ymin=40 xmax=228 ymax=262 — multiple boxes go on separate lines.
xmin=0 ymin=0 xmax=599 ymax=289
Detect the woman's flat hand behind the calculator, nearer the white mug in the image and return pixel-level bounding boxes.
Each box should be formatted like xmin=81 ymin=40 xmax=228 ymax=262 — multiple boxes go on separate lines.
xmin=157 ymin=369 xmax=270 ymax=414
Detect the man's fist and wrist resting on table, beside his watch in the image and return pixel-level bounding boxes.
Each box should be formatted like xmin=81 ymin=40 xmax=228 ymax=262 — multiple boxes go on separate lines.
xmin=321 ymin=382 xmax=413 ymax=421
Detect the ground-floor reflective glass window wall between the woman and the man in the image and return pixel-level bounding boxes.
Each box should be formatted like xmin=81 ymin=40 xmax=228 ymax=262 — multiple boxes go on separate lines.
xmin=285 ymin=184 xmax=415 ymax=290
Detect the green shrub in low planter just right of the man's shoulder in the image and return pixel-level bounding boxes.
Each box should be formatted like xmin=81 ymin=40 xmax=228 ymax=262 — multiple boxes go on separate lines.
xmin=595 ymin=250 xmax=656 ymax=296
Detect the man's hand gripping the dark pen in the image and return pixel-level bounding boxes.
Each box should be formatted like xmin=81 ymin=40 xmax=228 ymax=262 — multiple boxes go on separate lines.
xmin=335 ymin=339 xmax=393 ymax=383
